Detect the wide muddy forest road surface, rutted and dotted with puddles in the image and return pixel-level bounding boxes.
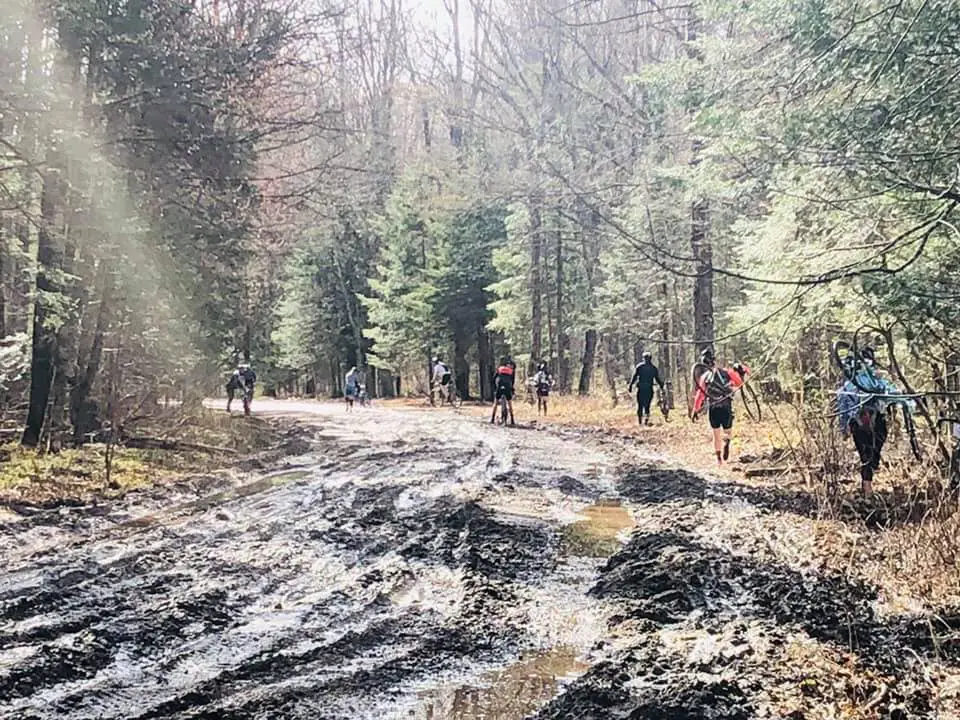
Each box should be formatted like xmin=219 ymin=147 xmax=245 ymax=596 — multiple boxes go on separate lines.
xmin=0 ymin=402 xmax=960 ymax=720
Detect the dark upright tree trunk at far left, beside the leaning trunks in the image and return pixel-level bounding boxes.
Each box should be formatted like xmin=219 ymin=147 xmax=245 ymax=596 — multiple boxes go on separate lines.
xmin=21 ymin=162 xmax=61 ymax=447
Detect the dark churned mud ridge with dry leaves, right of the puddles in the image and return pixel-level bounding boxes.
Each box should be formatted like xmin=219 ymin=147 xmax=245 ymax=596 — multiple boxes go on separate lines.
xmin=535 ymin=464 xmax=960 ymax=720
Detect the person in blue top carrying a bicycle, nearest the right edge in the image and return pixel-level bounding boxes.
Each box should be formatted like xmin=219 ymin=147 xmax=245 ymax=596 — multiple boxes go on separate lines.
xmin=837 ymin=347 xmax=914 ymax=496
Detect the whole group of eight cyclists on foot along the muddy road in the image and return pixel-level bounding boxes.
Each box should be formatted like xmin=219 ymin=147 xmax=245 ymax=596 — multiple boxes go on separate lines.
xmin=226 ymin=336 xmax=916 ymax=495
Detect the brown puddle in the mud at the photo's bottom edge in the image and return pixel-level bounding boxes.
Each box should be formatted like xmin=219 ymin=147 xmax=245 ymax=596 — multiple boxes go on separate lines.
xmin=413 ymin=647 xmax=590 ymax=720
